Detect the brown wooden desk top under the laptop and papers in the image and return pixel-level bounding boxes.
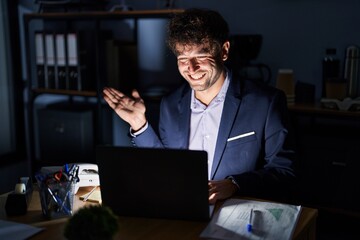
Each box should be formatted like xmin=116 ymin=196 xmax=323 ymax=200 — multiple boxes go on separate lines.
xmin=2 ymin=187 xmax=318 ymax=240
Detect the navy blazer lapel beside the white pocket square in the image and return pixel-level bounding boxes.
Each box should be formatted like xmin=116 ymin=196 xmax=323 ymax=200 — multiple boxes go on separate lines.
xmin=211 ymin=79 xmax=241 ymax=179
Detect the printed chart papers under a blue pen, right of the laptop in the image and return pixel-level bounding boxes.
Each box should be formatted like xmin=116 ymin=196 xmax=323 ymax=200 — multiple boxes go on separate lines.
xmin=200 ymin=199 xmax=302 ymax=240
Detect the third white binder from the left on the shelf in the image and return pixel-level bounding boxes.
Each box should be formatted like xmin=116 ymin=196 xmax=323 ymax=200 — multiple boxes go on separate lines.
xmin=55 ymin=33 xmax=67 ymax=89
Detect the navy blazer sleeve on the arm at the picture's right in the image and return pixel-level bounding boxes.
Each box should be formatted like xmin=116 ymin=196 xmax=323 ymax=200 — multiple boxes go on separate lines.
xmin=229 ymin=91 xmax=296 ymax=200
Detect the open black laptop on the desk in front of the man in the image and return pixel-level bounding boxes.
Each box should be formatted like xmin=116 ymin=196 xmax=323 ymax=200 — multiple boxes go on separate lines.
xmin=96 ymin=146 xmax=212 ymax=221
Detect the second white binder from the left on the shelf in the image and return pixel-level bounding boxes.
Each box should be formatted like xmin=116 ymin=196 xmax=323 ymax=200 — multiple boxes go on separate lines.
xmin=45 ymin=33 xmax=57 ymax=88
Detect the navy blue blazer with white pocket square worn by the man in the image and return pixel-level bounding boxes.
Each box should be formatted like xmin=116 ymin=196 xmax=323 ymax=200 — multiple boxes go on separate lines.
xmin=133 ymin=73 xmax=295 ymax=199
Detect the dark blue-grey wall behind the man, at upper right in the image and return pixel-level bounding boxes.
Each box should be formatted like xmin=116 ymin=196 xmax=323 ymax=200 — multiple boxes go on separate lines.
xmin=126 ymin=0 xmax=360 ymax=99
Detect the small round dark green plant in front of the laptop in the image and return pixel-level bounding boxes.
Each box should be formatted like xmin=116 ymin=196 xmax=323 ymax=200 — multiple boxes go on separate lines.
xmin=64 ymin=205 xmax=118 ymax=240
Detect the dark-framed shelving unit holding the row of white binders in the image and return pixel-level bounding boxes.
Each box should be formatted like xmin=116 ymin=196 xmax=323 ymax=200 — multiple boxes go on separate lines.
xmin=23 ymin=9 xmax=183 ymax=172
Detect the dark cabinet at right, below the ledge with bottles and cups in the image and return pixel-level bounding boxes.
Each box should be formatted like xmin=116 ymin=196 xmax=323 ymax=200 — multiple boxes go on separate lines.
xmin=289 ymin=104 xmax=360 ymax=218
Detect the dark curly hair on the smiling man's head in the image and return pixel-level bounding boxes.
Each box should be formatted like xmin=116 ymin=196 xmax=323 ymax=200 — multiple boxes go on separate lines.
xmin=167 ymin=8 xmax=229 ymax=55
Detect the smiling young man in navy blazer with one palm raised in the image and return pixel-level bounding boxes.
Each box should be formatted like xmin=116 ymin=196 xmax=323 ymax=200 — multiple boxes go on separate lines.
xmin=103 ymin=9 xmax=295 ymax=203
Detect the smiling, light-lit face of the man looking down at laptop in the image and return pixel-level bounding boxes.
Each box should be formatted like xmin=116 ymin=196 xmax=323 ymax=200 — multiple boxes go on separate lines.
xmin=176 ymin=42 xmax=230 ymax=94
